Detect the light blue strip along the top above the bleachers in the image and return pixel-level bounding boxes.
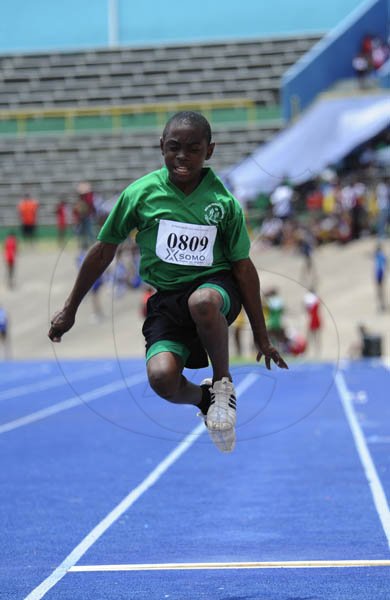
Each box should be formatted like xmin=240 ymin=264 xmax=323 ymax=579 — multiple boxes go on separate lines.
xmin=0 ymin=0 xmax=361 ymax=54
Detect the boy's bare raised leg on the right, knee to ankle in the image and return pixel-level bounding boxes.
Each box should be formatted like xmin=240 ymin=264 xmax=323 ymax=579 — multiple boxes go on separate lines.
xmin=188 ymin=287 xmax=230 ymax=381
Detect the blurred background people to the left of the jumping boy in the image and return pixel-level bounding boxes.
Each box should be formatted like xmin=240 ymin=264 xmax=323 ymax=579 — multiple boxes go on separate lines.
xmin=0 ymin=182 xmax=145 ymax=359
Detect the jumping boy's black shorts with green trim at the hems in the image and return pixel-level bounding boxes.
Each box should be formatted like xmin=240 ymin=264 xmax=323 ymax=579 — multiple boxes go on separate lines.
xmin=142 ymin=271 xmax=241 ymax=369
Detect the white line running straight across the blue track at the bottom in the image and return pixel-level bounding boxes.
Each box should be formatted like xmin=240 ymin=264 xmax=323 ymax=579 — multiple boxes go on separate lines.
xmin=68 ymin=560 xmax=390 ymax=573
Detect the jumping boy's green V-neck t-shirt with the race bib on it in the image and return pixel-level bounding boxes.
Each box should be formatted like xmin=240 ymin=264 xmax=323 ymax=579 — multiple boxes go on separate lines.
xmin=98 ymin=167 xmax=250 ymax=290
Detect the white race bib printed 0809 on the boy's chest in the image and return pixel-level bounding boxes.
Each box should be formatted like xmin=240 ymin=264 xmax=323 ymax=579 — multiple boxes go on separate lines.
xmin=156 ymin=219 xmax=217 ymax=267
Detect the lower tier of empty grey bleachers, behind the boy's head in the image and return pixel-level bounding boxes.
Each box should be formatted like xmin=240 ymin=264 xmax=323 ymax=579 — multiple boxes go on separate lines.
xmin=0 ymin=122 xmax=275 ymax=226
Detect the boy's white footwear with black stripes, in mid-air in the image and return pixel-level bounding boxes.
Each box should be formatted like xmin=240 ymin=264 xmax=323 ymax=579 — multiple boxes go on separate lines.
xmin=201 ymin=377 xmax=236 ymax=452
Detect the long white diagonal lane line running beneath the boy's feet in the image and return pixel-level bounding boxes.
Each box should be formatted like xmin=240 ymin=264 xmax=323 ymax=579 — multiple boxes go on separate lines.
xmin=24 ymin=374 xmax=257 ymax=600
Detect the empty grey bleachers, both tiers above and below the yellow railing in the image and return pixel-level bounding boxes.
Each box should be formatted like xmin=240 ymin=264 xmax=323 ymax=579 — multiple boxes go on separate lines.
xmin=0 ymin=36 xmax=319 ymax=226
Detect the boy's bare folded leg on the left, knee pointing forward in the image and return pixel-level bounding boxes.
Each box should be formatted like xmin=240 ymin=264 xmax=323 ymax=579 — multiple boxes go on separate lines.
xmin=147 ymin=352 xmax=202 ymax=406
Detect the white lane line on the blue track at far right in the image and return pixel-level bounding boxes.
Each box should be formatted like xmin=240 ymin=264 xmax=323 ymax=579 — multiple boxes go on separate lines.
xmin=335 ymin=371 xmax=390 ymax=548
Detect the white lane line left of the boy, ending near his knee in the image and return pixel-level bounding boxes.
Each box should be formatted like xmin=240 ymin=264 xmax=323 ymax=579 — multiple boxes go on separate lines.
xmin=0 ymin=373 xmax=146 ymax=434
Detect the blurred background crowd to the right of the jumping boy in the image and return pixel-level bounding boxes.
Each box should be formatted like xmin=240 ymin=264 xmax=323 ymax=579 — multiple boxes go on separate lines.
xmin=229 ymin=131 xmax=390 ymax=358
